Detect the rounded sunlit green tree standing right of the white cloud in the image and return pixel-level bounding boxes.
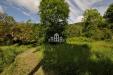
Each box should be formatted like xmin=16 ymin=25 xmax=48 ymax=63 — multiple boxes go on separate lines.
xmin=83 ymin=9 xmax=103 ymax=37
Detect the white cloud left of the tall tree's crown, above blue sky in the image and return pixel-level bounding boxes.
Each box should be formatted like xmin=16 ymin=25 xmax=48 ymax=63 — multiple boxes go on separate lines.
xmin=7 ymin=0 xmax=40 ymax=13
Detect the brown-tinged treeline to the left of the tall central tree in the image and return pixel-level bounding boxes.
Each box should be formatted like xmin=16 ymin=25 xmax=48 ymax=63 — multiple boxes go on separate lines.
xmin=0 ymin=16 xmax=39 ymax=45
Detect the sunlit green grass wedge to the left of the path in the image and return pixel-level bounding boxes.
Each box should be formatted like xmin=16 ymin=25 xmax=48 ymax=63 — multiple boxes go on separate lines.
xmin=0 ymin=45 xmax=30 ymax=72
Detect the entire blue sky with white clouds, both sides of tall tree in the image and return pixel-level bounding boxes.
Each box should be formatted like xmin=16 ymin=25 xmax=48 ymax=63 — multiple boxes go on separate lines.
xmin=0 ymin=0 xmax=113 ymax=24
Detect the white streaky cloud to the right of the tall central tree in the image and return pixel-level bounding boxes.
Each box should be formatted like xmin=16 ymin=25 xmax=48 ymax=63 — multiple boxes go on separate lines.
xmin=66 ymin=0 xmax=105 ymax=23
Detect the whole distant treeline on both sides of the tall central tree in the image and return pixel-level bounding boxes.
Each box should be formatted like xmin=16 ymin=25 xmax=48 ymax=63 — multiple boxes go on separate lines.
xmin=0 ymin=4 xmax=113 ymax=45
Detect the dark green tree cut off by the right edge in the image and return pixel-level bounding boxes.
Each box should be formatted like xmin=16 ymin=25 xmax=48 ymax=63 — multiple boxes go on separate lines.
xmin=104 ymin=3 xmax=113 ymax=29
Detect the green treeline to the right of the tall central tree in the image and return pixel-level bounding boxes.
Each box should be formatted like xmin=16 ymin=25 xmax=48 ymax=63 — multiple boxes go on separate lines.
xmin=66 ymin=4 xmax=113 ymax=40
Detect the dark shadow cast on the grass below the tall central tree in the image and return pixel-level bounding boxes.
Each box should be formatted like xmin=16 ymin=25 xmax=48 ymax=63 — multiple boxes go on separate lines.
xmin=42 ymin=44 xmax=113 ymax=75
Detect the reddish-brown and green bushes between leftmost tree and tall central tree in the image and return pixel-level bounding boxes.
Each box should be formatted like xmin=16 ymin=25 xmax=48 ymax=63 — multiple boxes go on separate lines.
xmin=12 ymin=23 xmax=40 ymax=44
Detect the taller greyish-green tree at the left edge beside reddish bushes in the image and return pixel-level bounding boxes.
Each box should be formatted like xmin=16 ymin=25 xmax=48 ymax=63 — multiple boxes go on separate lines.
xmin=0 ymin=15 xmax=16 ymax=44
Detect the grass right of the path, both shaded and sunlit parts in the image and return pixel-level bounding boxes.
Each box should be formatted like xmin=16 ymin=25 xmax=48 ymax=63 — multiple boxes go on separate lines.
xmin=43 ymin=37 xmax=113 ymax=75
